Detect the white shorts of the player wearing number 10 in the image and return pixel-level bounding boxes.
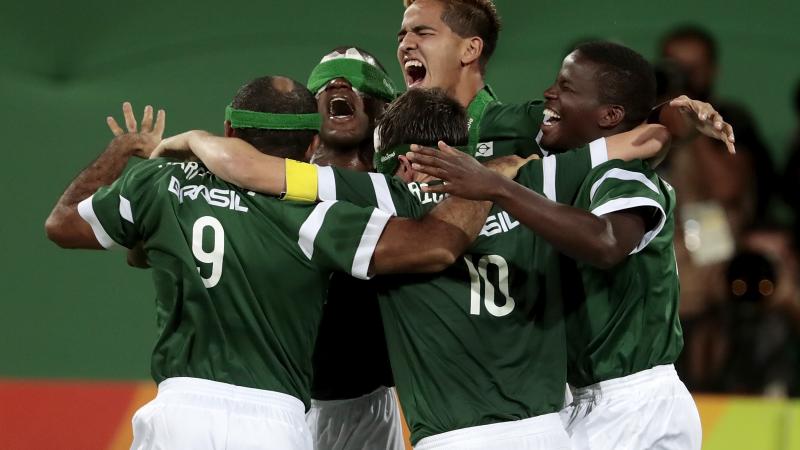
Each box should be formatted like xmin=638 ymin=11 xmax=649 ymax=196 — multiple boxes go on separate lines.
xmin=414 ymin=413 xmax=570 ymax=450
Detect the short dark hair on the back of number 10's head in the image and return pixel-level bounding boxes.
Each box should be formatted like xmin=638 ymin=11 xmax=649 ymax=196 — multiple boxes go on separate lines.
xmin=375 ymin=88 xmax=469 ymax=151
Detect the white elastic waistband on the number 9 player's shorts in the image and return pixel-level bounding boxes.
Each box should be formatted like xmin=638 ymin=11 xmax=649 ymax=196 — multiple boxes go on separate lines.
xmin=158 ymin=377 xmax=305 ymax=412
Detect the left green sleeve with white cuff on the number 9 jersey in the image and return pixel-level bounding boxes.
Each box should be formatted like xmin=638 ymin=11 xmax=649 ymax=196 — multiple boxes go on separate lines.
xmin=78 ymin=160 xmax=168 ymax=249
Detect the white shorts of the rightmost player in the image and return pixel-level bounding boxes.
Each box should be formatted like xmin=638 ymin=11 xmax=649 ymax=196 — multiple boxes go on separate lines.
xmin=561 ymin=364 xmax=703 ymax=450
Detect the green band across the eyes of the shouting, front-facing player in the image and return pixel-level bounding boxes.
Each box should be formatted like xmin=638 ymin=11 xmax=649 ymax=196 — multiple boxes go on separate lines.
xmin=307 ymin=58 xmax=397 ymax=102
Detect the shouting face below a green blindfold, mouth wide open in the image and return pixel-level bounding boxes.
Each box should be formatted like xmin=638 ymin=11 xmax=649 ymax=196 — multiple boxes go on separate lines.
xmin=317 ymin=78 xmax=370 ymax=147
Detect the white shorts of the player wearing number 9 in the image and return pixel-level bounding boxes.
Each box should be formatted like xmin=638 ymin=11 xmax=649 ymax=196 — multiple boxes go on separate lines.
xmin=131 ymin=377 xmax=313 ymax=450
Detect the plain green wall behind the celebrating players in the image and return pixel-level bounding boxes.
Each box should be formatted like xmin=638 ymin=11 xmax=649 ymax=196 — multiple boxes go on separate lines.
xmin=0 ymin=0 xmax=800 ymax=379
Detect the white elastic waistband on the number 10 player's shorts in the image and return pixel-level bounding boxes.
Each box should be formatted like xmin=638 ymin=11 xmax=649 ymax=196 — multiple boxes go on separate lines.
xmin=414 ymin=413 xmax=564 ymax=450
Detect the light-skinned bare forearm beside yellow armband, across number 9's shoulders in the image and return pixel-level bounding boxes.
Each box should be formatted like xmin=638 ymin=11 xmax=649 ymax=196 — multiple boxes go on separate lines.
xmin=189 ymin=135 xmax=286 ymax=195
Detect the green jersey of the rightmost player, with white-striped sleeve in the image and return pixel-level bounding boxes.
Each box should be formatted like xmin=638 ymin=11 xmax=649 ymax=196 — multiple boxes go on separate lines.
xmin=562 ymin=160 xmax=683 ymax=387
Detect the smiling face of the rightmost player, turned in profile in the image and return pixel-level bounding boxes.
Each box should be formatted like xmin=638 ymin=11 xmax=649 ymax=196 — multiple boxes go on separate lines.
xmin=540 ymin=52 xmax=605 ymax=150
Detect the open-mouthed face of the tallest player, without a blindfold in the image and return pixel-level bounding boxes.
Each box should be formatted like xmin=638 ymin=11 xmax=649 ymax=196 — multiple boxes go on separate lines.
xmin=397 ymin=0 xmax=469 ymax=93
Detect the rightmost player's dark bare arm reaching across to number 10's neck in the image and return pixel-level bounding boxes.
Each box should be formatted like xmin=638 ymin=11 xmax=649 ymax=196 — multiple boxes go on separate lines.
xmin=408 ymin=141 xmax=655 ymax=268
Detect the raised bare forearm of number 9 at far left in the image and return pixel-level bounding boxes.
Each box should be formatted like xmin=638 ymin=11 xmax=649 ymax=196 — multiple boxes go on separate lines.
xmin=45 ymin=134 xmax=139 ymax=248
